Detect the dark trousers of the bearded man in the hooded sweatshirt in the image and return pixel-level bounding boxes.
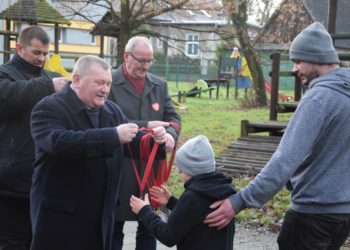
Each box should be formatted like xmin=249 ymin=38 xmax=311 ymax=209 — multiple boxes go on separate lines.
xmin=277 ymin=209 xmax=350 ymax=250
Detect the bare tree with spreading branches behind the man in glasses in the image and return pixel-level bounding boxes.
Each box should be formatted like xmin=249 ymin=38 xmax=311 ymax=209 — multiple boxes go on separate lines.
xmin=54 ymin=0 xmax=232 ymax=64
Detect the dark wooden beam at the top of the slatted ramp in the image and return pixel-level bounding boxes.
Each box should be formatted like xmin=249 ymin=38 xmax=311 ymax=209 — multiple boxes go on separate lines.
xmin=241 ymin=120 xmax=288 ymax=137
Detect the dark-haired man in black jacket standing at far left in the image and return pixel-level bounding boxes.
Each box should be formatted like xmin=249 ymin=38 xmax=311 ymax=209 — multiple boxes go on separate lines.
xmin=0 ymin=26 xmax=68 ymax=249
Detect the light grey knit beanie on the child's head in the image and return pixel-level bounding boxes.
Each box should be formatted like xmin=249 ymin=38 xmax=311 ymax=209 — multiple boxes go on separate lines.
xmin=175 ymin=135 xmax=215 ymax=176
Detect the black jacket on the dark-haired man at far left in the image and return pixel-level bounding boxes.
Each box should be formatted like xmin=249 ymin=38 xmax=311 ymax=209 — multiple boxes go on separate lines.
xmin=0 ymin=54 xmax=59 ymax=197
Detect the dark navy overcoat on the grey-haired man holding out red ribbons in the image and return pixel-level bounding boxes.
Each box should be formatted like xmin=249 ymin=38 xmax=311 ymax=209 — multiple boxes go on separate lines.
xmin=30 ymin=85 xmax=164 ymax=250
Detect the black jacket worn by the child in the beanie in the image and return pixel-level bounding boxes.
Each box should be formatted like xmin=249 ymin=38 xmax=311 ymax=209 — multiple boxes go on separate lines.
xmin=139 ymin=172 xmax=236 ymax=250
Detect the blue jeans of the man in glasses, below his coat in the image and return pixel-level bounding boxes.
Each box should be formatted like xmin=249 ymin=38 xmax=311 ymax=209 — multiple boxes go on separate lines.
xmin=112 ymin=221 xmax=157 ymax=250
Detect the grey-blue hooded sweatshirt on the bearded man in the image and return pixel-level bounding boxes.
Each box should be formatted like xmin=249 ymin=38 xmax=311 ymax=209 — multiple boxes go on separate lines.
xmin=230 ymin=68 xmax=350 ymax=214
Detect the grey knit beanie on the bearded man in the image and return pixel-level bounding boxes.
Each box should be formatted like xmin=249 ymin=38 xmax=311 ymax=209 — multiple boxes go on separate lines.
xmin=289 ymin=22 xmax=339 ymax=64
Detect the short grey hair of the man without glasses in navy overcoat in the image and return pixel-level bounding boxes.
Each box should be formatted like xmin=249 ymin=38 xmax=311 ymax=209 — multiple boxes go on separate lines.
xmin=73 ymin=55 xmax=111 ymax=76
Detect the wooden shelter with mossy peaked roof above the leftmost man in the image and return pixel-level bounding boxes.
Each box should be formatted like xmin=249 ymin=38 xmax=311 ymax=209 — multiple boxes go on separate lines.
xmin=0 ymin=0 xmax=69 ymax=62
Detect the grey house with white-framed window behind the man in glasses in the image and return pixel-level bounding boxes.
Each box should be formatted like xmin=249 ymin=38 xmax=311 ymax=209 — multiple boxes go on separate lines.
xmin=151 ymin=9 xmax=260 ymax=75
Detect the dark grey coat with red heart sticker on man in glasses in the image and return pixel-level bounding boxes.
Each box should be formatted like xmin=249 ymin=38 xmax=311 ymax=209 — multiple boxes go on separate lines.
xmin=109 ymin=66 xmax=181 ymax=221
